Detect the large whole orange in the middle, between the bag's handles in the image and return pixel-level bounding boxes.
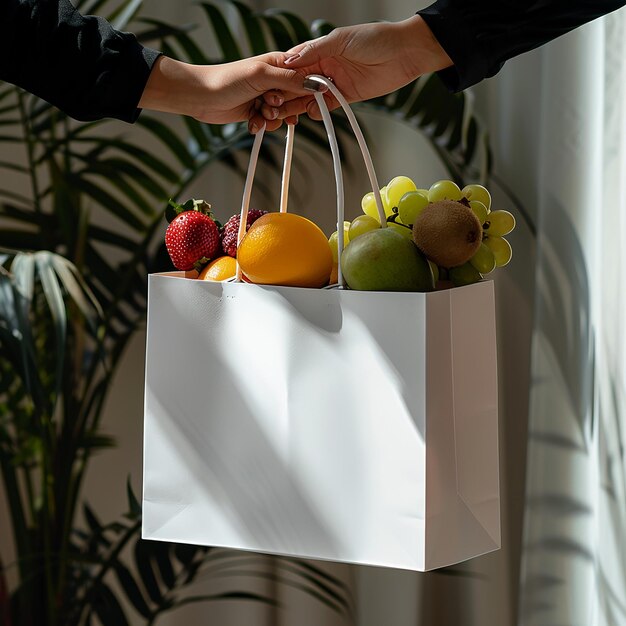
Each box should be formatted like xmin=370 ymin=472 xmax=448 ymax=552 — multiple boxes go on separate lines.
xmin=237 ymin=213 xmax=333 ymax=287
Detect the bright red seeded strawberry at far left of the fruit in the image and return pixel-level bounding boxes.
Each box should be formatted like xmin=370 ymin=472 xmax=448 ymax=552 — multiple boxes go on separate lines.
xmin=165 ymin=211 xmax=220 ymax=270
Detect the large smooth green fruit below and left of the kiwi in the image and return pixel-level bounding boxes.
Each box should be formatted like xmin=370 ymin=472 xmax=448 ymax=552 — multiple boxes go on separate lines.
xmin=341 ymin=228 xmax=435 ymax=291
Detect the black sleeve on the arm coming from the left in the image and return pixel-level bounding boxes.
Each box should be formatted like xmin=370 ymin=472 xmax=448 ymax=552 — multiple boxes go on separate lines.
xmin=0 ymin=0 xmax=160 ymax=122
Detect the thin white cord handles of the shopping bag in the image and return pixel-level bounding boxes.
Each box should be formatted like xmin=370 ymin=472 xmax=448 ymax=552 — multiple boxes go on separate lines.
xmin=237 ymin=74 xmax=387 ymax=288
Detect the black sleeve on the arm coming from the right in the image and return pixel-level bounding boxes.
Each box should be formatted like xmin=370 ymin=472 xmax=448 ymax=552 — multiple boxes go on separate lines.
xmin=418 ymin=0 xmax=626 ymax=91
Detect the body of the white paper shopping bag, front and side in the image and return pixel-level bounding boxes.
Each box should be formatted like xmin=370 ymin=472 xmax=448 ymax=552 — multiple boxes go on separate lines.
xmin=143 ymin=75 xmax=500 ymax=571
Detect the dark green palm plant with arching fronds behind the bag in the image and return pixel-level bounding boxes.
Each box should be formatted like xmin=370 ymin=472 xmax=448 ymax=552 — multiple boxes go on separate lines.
xmin=0 ymin=0 xmax=489 ymax=626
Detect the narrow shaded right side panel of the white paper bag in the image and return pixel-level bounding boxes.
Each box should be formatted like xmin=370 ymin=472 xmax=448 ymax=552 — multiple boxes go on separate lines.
xmin=426 ymin=283 xmax=499 ymax=569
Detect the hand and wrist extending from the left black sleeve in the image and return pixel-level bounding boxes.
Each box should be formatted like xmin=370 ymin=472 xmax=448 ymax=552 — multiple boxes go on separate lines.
xmin=138 ymin=53 xmax=322 ymax=133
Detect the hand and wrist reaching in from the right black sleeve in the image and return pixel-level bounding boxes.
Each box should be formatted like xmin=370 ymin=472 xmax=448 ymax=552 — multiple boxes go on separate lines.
xmin=279 ymin=15 xmax=452 ymax=119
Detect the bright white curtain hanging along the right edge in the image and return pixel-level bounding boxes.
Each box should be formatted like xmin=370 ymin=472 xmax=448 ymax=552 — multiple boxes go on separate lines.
xmin=518 ymin=6 xmax=626 ymax=626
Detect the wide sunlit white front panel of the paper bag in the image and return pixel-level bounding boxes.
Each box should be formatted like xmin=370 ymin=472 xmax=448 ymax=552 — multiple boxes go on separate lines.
xmin=143 ymin=276 xmax=426 ymax=569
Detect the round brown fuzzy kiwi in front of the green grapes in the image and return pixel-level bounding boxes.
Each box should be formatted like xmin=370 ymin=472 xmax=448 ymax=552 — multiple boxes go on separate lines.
xmin=413 ymin=200 xmax=483 ymax=267
